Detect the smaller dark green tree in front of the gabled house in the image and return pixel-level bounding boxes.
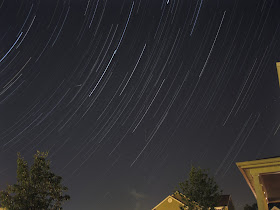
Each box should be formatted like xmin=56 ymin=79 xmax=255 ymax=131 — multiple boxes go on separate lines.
xmin=179 ymin=166 xmax=222 ymax=209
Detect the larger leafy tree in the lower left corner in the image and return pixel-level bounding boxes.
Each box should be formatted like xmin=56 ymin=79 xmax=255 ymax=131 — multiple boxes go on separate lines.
xmin=0 ymin=151 xmax=70 ymax=210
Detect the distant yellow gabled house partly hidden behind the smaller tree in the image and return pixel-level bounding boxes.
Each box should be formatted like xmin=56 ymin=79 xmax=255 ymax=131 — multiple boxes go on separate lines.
xmin=152 ymin=192 xmax=234 ymax=210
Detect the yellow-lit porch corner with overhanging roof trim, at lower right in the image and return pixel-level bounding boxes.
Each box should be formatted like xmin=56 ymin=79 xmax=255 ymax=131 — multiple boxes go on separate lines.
xmin=236 ymin=157 xmax=280 ymax=210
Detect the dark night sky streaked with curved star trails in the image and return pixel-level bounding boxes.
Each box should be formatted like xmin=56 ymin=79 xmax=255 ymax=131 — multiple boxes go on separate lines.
xmin=0 ymin=0 xmax=280 ymax=210
